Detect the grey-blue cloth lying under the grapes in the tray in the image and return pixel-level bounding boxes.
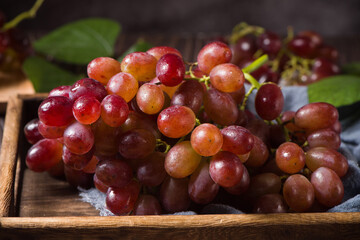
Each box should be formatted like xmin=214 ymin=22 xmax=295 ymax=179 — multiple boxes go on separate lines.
xmin=80 ymin=86 xmax=360 ymax=216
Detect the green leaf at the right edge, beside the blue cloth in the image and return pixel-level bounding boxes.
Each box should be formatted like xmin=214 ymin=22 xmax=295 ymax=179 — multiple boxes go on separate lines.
xmin=308 ymin=75 xmax=360 ymax=107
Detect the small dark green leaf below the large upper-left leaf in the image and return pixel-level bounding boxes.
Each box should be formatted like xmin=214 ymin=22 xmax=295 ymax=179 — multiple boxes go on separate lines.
xmin=23 ymin=57 xmax=79 ymax=92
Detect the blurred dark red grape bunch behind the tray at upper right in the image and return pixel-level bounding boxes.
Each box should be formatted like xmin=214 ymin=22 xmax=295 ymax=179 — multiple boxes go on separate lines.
xmin=230 ymin=23 xmax=340 ymax=85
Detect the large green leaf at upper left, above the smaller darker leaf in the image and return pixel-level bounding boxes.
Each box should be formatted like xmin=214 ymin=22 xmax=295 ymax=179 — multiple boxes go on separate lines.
xmin=34 ymin=18 xmax=120 ymax=64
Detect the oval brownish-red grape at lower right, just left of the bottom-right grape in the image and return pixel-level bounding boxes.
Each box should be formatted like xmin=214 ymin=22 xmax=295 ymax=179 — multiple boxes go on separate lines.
xmin=283 ymin=174 xmax=315 ymax=212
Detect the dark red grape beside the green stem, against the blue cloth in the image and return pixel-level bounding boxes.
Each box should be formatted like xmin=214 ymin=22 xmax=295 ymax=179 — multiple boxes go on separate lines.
xmin=255 ymin=84 xmax=284 ymax=121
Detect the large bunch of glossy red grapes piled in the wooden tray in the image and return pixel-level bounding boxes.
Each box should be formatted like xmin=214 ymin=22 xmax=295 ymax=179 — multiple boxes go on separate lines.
xmin=25 ymin=41 xmax=348 ymax=215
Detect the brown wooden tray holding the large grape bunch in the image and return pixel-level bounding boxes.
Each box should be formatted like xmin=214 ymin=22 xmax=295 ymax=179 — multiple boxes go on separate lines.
xmin=0 ymin=94 xmax=360 ymax=239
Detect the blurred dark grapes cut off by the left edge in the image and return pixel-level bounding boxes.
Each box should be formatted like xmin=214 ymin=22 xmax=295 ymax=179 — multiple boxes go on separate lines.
xmin=0 ymin=10 xmax=32 ymax=72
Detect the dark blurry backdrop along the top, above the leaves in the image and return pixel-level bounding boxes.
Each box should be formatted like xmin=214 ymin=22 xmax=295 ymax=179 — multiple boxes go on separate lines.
xmin=0 ymin=0 xmax=360 ymax=37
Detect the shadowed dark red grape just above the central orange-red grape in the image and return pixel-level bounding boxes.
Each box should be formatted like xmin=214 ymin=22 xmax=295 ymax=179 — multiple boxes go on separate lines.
xmin=171 ymin=79 xmax=204 ymax=113
